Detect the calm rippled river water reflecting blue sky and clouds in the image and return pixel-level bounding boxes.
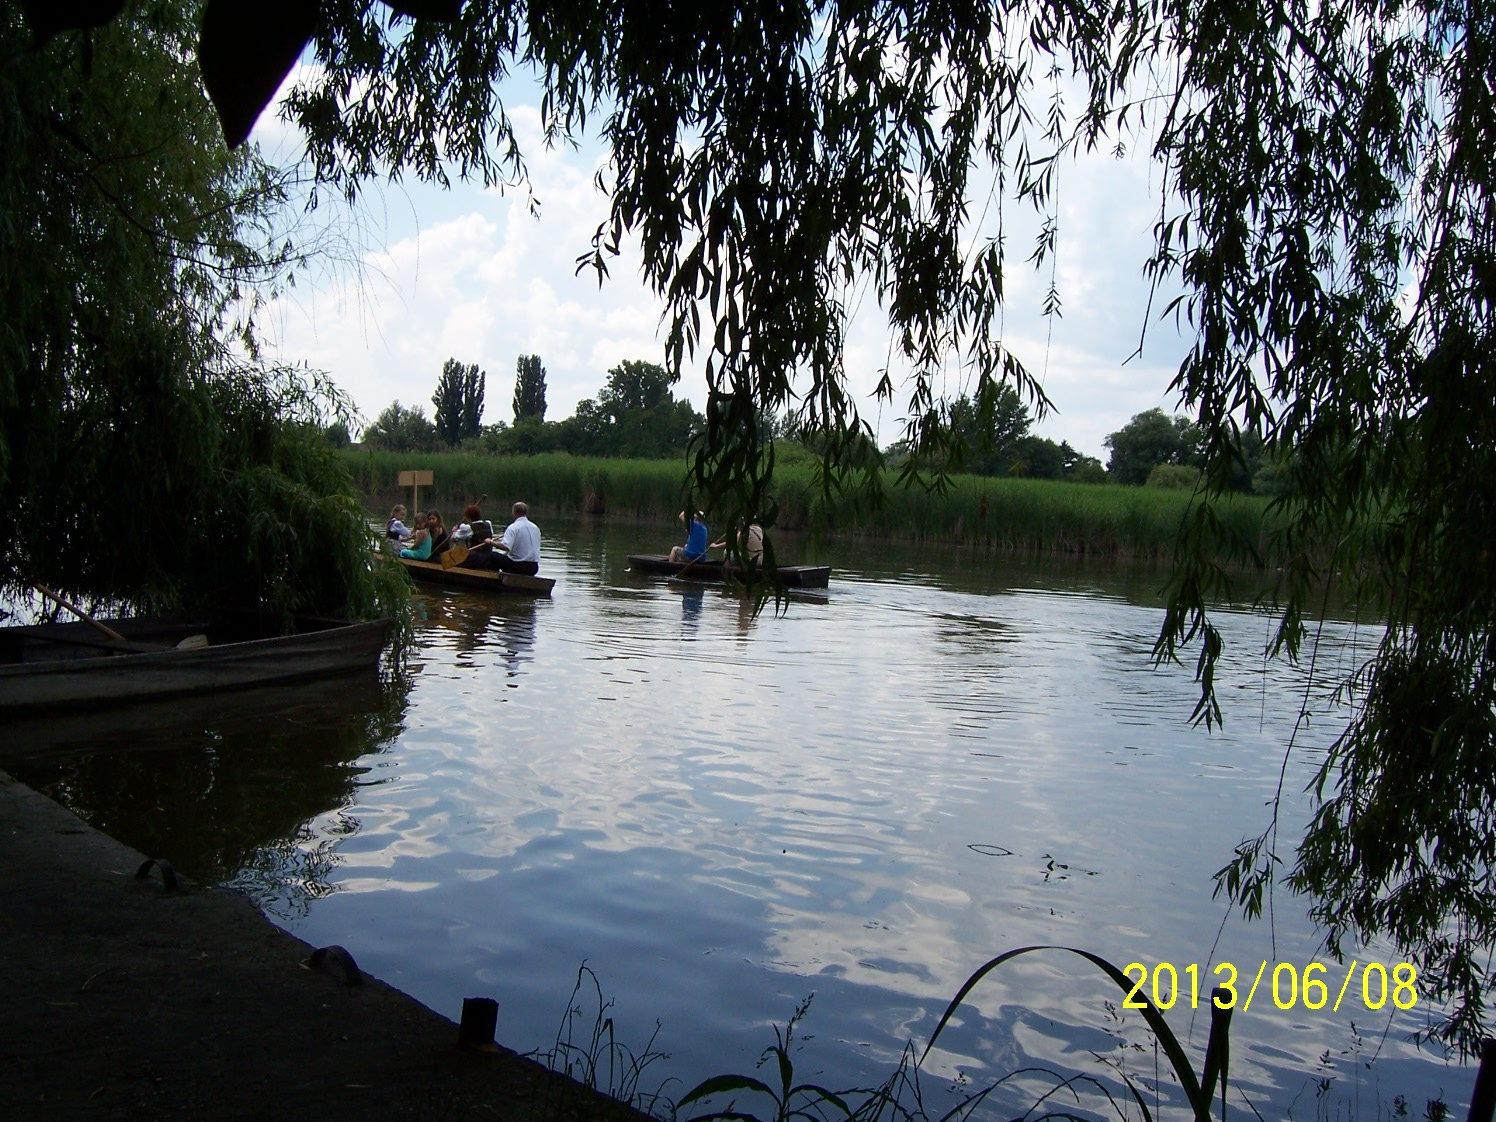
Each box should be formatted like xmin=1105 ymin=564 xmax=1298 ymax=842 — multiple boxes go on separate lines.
xmin=0 ymin=521 xmax=1474 ymax=1119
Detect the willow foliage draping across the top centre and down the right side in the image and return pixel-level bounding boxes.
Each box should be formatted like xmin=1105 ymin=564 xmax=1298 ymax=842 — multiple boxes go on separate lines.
xmin=26 ymin=0 xmax=1496 ymax=1043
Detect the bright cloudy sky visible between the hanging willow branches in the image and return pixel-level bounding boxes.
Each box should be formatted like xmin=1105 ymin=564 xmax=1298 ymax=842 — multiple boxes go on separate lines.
xmin=253 ymin=66 xmax=1186 ymax=462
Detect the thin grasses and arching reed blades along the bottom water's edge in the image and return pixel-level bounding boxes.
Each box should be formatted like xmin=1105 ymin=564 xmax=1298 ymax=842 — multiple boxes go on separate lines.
xmin=531 ymin=945 xmax=1450 ymax=1122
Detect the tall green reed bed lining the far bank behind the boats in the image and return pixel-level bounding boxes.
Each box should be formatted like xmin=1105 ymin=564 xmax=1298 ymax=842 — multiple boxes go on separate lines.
xmin=346 ymin=450 xmax=1273 ymax=560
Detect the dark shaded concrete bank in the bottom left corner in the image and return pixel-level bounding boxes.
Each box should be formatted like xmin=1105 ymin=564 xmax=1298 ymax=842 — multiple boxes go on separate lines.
xmin=0 ymin=772 xmax=645 ymax=1122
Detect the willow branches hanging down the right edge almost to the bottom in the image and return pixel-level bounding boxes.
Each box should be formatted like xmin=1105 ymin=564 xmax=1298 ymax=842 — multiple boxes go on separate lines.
xmin=1153 ymin=3 xmax=1496 ymax=1046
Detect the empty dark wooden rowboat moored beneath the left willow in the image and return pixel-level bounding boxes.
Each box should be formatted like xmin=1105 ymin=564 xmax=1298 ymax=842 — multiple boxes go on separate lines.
xmin=0 ymin=613 xmax=390 ymax=714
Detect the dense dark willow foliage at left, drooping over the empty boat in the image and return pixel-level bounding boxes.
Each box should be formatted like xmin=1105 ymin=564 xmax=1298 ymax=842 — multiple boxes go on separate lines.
xmin=0 ymin=3 xmax=398 ymax=628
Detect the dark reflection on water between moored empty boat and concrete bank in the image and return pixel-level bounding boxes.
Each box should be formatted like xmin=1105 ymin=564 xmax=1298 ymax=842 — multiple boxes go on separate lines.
xmin=0 ymin=673 xmax=410 ymax=911
